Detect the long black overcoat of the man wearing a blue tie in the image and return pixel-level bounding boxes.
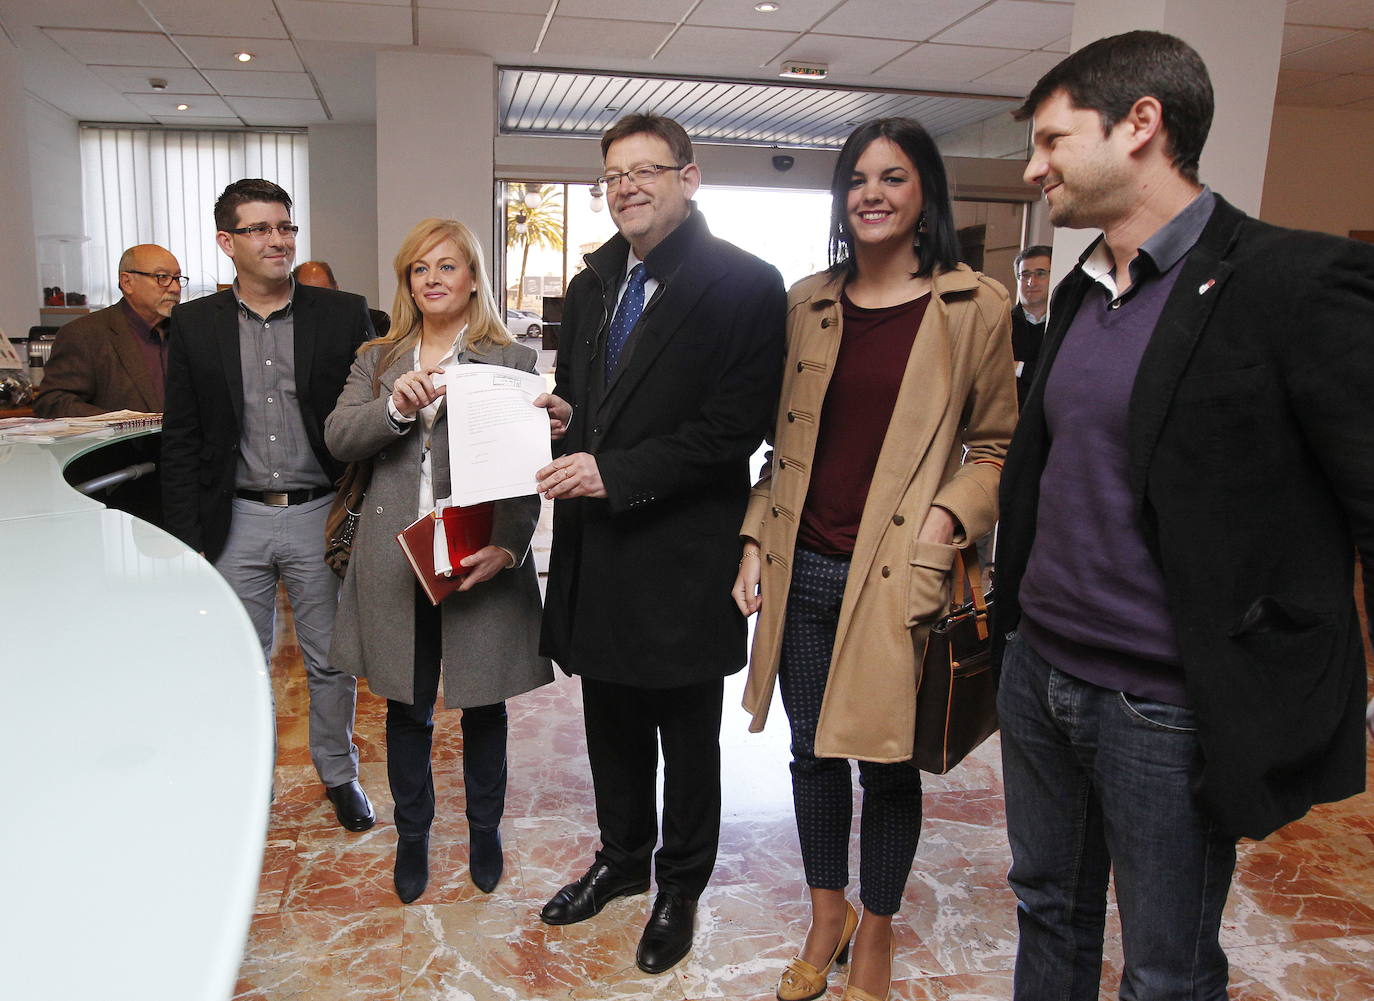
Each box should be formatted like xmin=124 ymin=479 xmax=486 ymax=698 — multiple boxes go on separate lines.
xmin=541 ymin=209 xmax=787 ymax=688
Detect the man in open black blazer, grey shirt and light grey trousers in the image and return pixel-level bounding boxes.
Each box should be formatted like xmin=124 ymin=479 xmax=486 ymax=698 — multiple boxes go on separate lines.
xmin=162 ymin=179 xmax=375 ymax=831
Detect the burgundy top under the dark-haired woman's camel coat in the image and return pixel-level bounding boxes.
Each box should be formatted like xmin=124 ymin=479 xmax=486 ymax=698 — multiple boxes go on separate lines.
xmin=797 ymin=288 xmax=930 ymax=556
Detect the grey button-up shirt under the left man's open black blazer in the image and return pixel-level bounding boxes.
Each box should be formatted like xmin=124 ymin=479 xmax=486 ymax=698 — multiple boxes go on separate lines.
xmin=234 ymin=283 xmax=330 ymax=492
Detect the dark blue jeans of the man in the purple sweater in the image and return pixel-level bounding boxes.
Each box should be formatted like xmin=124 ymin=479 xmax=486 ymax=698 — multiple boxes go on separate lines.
xmin=998 ymin=636 xmax=1235 ymax=1001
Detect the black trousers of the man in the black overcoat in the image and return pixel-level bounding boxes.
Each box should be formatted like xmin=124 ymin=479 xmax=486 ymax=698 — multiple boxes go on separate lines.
xmin=583 ymin=678 xmax=724 ymax=901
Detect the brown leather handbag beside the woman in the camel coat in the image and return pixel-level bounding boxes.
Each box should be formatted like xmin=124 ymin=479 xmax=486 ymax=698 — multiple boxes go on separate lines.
xmin=910 ymin=545 xmax=998 ymax=774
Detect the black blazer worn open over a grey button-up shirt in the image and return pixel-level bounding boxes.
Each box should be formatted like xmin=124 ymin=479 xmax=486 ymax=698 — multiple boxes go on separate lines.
xmin=162 ymin=284 xmax=372 ymax=560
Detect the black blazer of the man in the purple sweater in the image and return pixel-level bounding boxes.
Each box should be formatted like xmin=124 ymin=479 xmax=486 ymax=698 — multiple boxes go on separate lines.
xmin=993 ymin=199 xmax=1374 ymax=838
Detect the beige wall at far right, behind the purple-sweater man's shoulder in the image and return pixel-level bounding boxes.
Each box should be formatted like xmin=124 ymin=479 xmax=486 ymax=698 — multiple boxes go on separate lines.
xmin=1260 ymin=107 xmax=1374 ymax=236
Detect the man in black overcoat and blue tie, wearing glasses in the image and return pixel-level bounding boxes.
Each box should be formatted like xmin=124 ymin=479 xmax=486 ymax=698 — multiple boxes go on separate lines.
xmin=524 ymin=115 xmax=786 ymax=974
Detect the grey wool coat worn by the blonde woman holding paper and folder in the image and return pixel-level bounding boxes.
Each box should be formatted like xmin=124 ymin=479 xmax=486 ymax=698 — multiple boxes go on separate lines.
xmin=324 ymin=343 xmax=554 ymax=707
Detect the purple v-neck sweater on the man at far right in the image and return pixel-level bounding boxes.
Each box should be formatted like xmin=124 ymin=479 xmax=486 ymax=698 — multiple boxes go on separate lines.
xmin=1021 ymin=189 xmax=1215 ymax=706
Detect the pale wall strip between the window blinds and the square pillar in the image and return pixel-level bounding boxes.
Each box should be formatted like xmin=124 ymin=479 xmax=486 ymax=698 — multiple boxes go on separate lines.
xmin=309 ymin=125 xmax=379 ymax=304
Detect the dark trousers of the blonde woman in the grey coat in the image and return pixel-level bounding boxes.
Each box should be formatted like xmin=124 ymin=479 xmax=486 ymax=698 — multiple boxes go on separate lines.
xmin=386 ymin=585 xmax=506 ymax=839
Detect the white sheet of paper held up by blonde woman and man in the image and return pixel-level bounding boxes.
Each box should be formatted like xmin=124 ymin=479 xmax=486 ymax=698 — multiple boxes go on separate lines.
xmin=444 ymin=365 xmax=554 ymax=507
